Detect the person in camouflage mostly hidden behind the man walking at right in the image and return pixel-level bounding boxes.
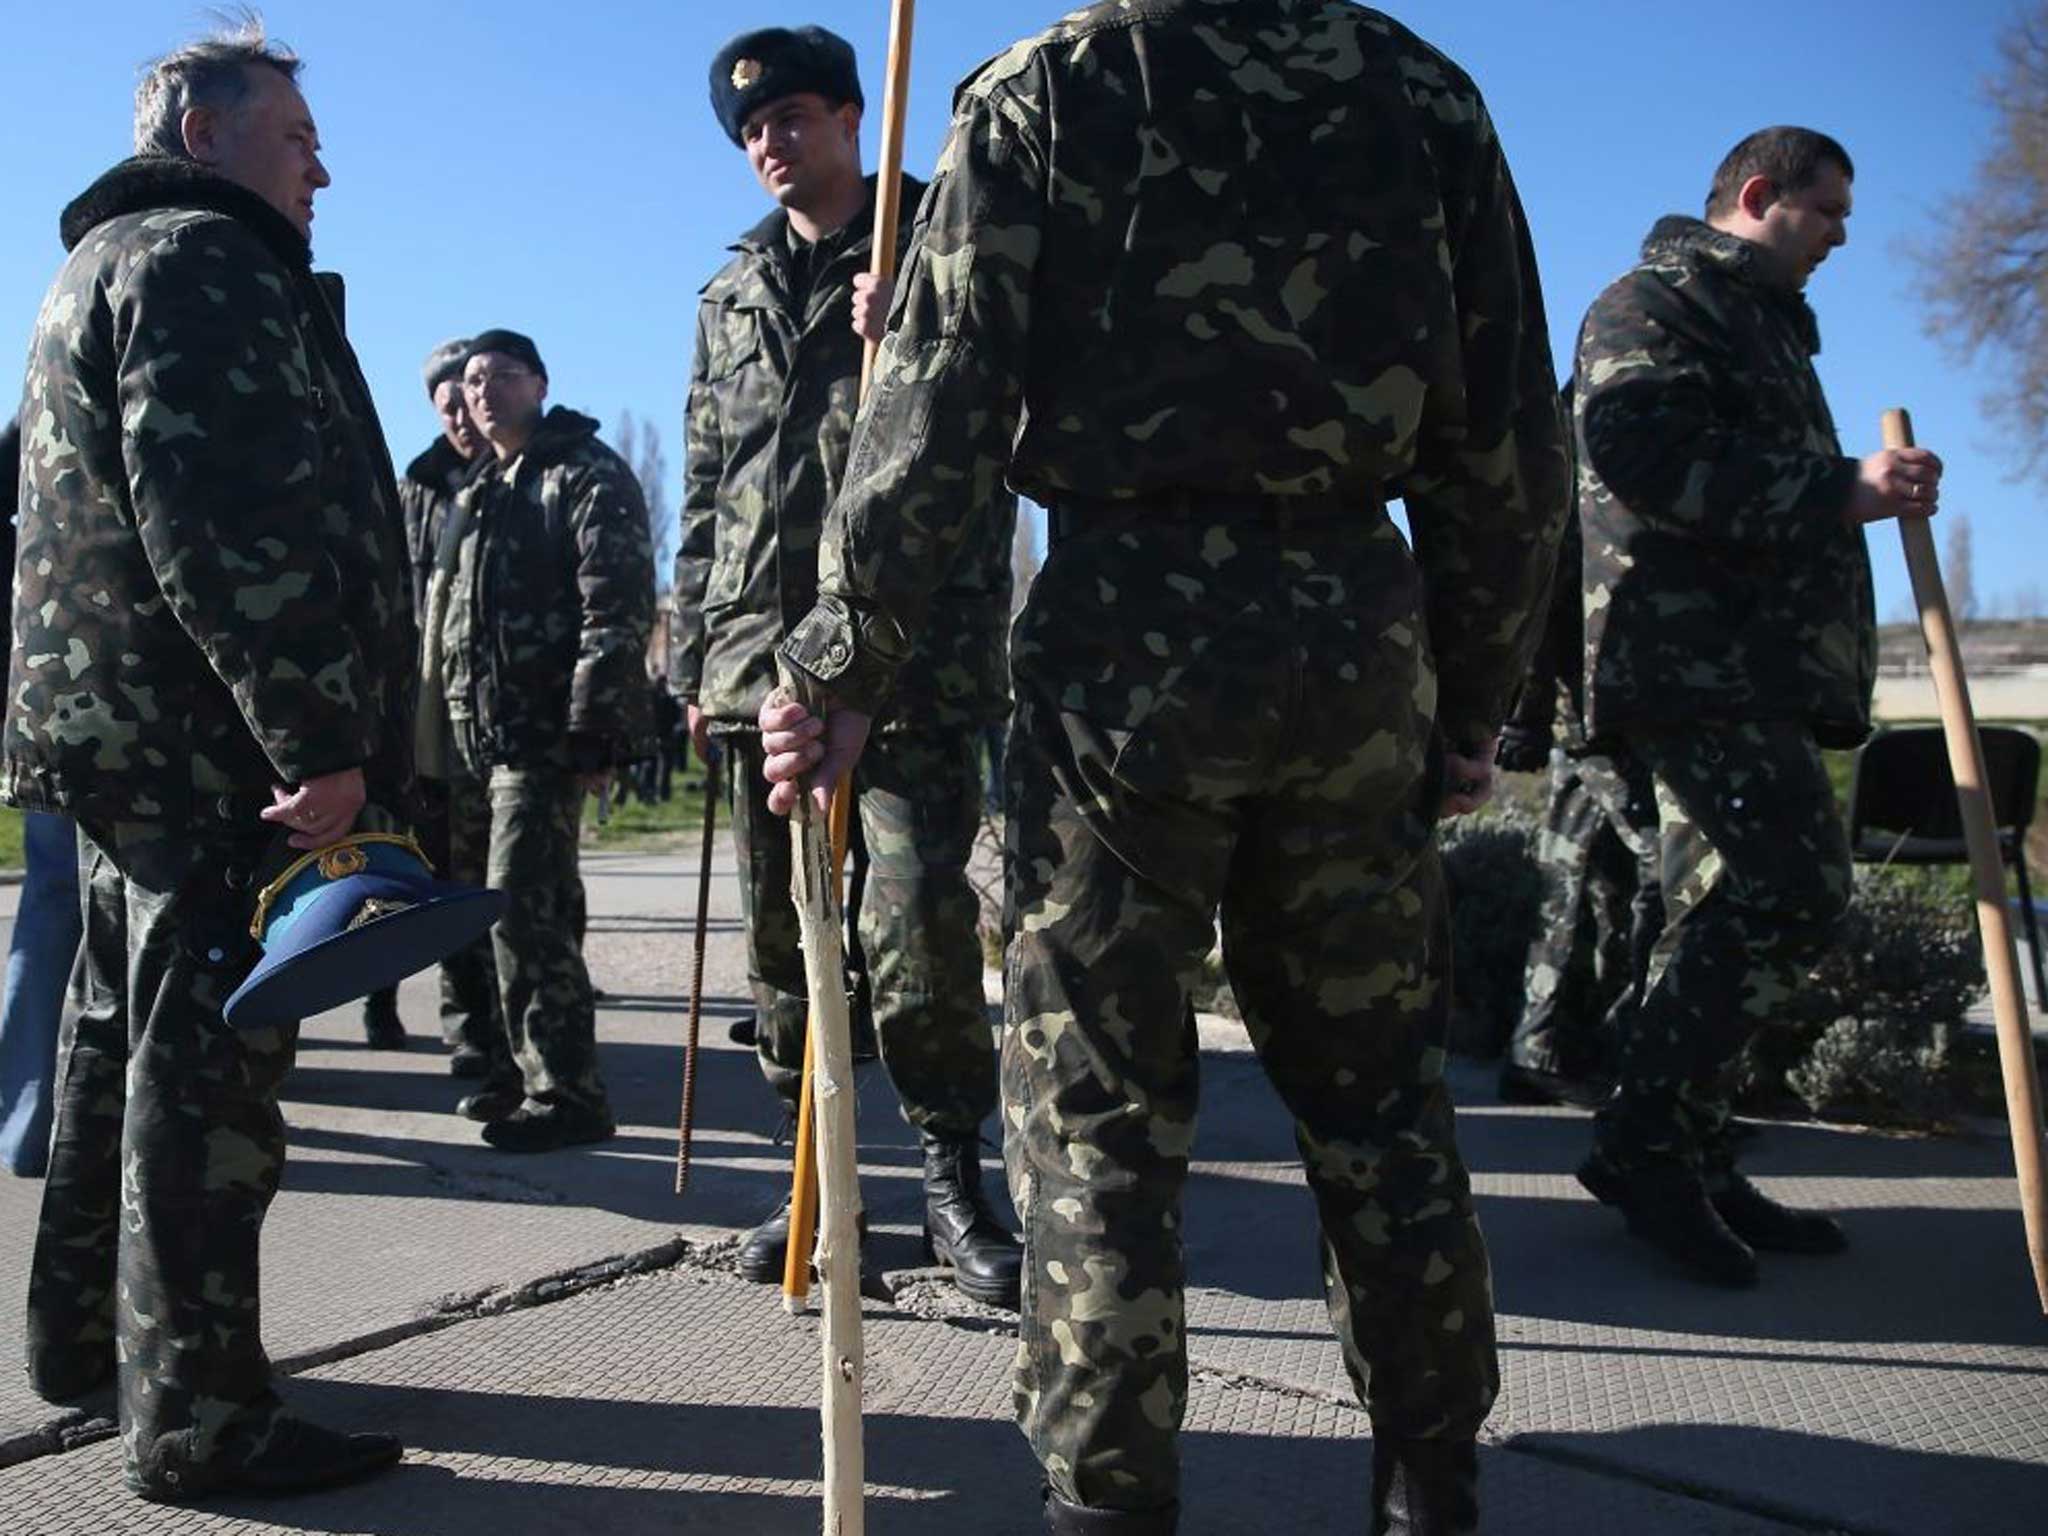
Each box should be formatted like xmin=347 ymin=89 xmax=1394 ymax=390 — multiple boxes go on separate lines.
xmin=1495 ymin=421 xmax=1663 ymax=1108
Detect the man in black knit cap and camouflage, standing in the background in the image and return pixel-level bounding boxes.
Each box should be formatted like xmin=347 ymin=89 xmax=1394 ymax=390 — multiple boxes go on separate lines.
xmin=422 ymin=330 xmax=653 ymax=1153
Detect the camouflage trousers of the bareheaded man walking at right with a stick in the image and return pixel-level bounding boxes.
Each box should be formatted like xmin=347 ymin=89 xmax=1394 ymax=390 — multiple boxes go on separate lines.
xmin=1595 ymin=721 xmax=1851 ymax=1174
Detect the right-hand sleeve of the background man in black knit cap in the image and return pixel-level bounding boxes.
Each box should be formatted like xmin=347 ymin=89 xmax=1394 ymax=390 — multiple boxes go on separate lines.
xmin=569 ymin=463 xmax=653 ymax=748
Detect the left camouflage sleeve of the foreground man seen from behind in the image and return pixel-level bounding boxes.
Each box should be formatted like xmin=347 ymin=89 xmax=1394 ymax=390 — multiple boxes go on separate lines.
xmin=782 ymin=81 xmax=1044 ymax=713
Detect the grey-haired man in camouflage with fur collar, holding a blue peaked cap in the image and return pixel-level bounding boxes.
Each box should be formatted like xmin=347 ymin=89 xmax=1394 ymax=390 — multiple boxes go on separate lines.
xmin=0 ymin=29 xmax=412 ymax=1501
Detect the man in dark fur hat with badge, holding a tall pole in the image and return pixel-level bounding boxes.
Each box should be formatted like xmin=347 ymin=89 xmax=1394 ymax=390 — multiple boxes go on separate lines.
xmin=672 ymin=29 xmax=1022 ymax=1307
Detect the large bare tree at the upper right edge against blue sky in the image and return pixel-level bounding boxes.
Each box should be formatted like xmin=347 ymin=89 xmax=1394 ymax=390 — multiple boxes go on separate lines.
xmin=1913 ymin=0 xmax=2048 ymax=473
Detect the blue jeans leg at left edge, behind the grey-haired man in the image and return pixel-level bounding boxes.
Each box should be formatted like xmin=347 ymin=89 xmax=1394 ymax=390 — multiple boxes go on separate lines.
xmin=0 ymin=811 xmax=82 ymax=1178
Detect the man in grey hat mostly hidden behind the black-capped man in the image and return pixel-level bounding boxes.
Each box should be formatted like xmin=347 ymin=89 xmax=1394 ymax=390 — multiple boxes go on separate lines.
xmin=401 ymin=336 xmax=510 ymax=1077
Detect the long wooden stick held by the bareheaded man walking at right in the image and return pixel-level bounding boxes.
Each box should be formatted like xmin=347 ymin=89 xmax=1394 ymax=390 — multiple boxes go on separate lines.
xmin=1884 ymin=410 xmax=2048 ymax=1313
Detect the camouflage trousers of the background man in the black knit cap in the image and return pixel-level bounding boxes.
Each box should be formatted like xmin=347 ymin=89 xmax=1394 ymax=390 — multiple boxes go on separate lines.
xmin=442 ymin=764 xmax=606 ymax=1112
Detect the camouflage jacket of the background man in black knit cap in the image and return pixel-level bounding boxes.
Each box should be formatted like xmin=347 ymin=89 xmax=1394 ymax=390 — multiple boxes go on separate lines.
xmin=436 ymin=406 xmax=653 ymax=772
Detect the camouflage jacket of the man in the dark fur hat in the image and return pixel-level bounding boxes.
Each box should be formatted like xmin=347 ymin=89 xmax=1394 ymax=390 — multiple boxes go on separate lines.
xmin=670 ymin=176 xmax=1016 ymax=729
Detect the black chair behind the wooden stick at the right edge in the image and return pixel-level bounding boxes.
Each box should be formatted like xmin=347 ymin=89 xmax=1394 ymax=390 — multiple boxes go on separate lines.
xmin=1849 ymin=725 xmax=2048 ymax=1008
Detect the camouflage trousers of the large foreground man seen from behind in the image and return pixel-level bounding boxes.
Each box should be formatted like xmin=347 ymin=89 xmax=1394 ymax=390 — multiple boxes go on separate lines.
xmin=1001 ymin=512 xmax=1499 ymax=1511
